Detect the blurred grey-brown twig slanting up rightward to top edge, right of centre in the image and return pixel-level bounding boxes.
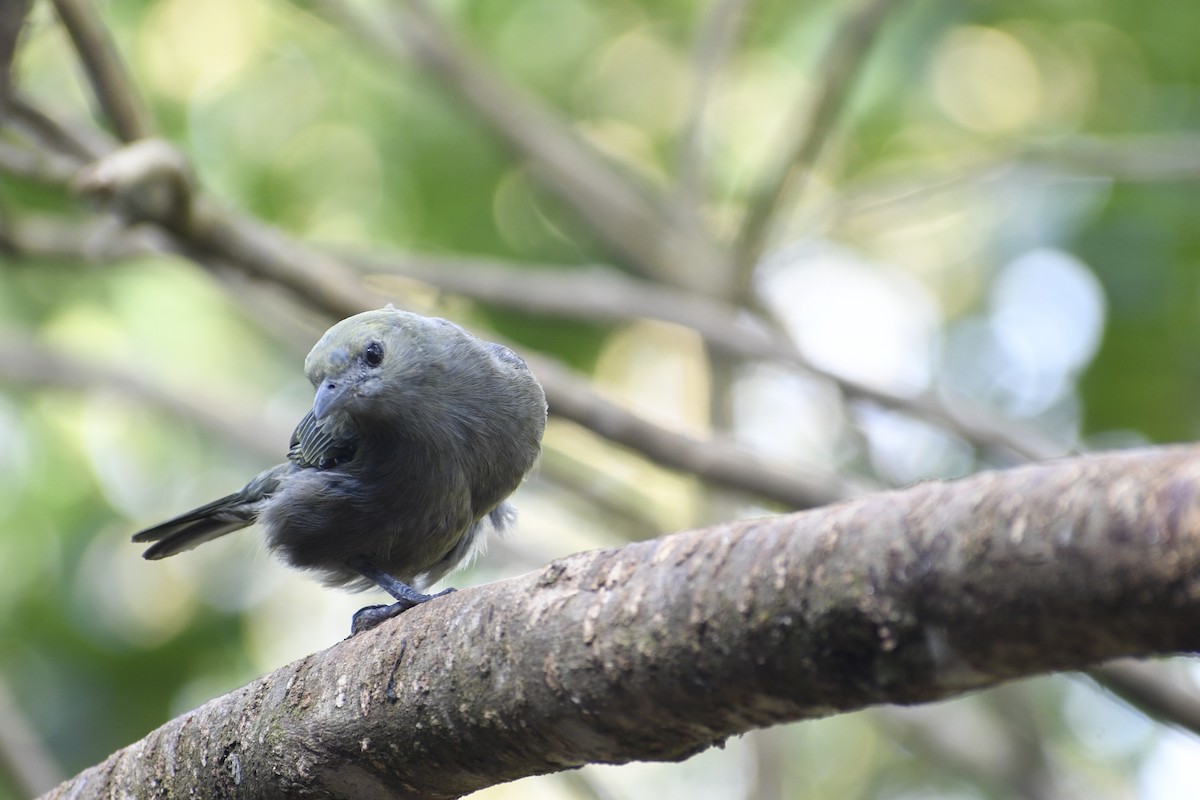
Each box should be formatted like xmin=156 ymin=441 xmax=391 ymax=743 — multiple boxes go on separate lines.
xmin=733 ymin=0 xmax=896 ymax=296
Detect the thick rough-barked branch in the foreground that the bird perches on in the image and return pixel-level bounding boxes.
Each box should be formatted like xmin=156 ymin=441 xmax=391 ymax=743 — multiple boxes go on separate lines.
xmin=39 ymin=447 xmax=1200 ymax=798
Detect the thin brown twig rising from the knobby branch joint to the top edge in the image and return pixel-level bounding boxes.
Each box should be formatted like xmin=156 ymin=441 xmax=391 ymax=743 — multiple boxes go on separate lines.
xmin=53 ymin=0 xmax=154 ymax=142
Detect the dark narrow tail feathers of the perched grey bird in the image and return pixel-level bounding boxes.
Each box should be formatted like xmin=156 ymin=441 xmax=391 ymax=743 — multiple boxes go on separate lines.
xmin=133 ymin=464 xmax=288 ymax=559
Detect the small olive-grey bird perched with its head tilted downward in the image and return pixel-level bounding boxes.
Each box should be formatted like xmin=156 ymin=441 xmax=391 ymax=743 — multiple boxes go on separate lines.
xmin=133 ymin=305 xmax=547 ymax=636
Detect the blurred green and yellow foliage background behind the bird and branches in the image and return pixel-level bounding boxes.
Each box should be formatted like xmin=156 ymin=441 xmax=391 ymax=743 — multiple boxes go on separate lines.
xmin=0 ymin=0 xmax=1200 ymax=799
